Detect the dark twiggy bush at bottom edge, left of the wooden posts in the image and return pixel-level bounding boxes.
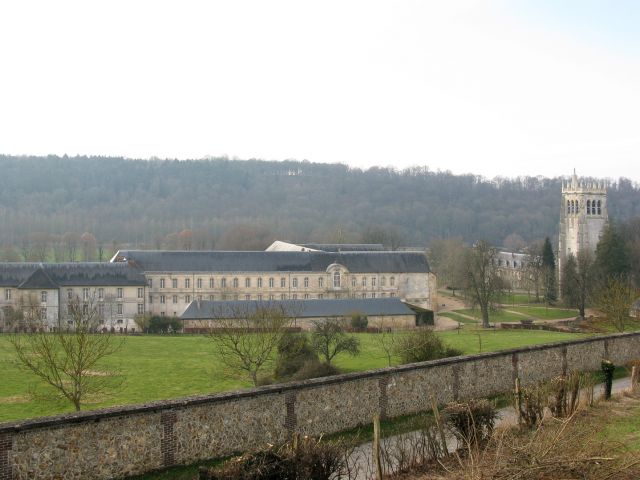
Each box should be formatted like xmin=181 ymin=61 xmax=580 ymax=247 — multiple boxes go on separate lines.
xmin=200 ymin=437 xmax=349 ymax=480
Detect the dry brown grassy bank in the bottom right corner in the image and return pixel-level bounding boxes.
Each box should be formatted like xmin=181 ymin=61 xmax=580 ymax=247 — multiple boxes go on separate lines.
xmin=398 ymin=395 xmax=640 ymax=480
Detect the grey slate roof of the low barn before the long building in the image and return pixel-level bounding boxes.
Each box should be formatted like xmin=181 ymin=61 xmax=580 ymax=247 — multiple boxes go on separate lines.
xmin=180 ymin=298 xmax=416 ymax=320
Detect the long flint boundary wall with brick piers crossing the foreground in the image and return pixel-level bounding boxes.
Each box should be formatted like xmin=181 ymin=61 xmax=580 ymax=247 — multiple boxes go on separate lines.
xmin=0 ymin=333 xmax=640 ymax=480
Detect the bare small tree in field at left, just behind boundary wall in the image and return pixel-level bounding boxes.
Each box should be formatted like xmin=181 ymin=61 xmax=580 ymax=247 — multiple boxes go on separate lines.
xmin=9 ymin=298 xmax=123 ymax=411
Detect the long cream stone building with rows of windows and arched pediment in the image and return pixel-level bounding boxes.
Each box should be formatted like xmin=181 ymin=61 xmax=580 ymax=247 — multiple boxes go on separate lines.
xmin=112 ymin=250 xmax=437 ymax=316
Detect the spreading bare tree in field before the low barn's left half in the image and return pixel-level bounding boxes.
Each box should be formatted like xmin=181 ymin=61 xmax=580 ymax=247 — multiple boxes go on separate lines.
xmin=207 ymin=303 xmax=293 ymax=386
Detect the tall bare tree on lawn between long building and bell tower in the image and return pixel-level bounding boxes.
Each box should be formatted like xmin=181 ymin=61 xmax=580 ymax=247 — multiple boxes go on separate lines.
xmin=465 ymin=240 xmax=504 ymax=328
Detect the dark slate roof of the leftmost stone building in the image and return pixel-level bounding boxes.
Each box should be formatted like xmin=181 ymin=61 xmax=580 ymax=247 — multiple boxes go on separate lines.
xmin=0 ymin=262 xmax=146 ymax=289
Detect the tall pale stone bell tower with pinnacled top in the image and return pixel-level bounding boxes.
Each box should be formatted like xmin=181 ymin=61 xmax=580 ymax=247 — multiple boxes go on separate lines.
xmin=558 ymin=170 xmax=608 ymax=278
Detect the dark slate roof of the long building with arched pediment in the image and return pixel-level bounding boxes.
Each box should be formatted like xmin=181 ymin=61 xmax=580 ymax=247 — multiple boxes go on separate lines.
xmin=112 ymin=250 xmax=431 ymax=273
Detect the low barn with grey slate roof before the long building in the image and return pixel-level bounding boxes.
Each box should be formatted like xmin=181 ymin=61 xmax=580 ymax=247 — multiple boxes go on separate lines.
xmin=180 ymin=298 xmax=433 ymax=332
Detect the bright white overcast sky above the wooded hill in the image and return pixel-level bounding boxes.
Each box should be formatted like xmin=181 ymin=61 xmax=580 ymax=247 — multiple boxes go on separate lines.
xmin=0 ymin=0 xmax=640 ymax=181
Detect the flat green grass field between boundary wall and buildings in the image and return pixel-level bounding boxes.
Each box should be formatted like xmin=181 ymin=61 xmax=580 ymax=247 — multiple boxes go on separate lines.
xmin=0 ymin=328 xmax=581 ymax=421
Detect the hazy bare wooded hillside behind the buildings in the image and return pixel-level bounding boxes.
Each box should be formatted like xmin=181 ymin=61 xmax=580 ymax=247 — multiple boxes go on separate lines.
xmin=0 ymin=155 xmax=640 ymax=261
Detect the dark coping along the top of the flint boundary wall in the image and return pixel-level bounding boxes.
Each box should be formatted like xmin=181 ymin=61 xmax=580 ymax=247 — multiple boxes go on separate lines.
xmin=0 ymin=332 xmax=640 ymax=434
